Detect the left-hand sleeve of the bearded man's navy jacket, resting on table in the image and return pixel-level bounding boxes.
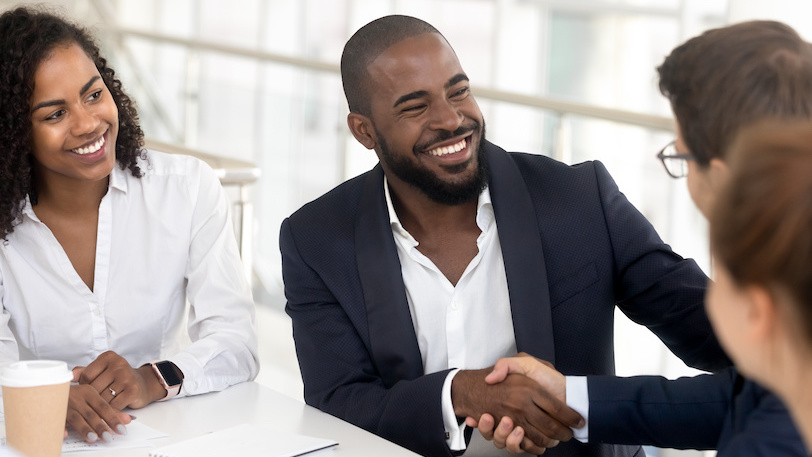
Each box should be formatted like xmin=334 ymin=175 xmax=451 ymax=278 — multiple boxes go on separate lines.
xmin=280 ymin=220 xmax=452 ymax=456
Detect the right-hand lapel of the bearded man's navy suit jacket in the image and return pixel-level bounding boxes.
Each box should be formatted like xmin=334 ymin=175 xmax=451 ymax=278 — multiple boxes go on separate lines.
xmin=486 ymin=143 xmax=555 ymax=364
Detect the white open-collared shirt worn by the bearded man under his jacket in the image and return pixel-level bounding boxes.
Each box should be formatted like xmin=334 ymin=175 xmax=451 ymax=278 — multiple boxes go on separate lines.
xmin=384 ymin=180 xmax=516 ymax=450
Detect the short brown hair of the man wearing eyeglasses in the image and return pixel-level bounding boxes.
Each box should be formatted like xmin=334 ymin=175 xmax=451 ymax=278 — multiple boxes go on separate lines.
xmin=657 ymin=21 xmax=812 ymax=166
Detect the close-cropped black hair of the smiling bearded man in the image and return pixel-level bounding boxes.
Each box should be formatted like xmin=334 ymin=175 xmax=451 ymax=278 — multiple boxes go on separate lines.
xmin=341 ymin=15 xmax=442 ymax=115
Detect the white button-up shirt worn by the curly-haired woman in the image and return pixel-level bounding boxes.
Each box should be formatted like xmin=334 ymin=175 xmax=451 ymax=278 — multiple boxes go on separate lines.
xmin=0 ymin=152 xmax=259 ymax=395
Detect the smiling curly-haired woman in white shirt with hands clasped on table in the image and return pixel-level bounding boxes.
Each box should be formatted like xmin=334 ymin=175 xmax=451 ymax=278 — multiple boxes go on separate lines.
xmin=0 ymin=8 xmax=258 ymax=442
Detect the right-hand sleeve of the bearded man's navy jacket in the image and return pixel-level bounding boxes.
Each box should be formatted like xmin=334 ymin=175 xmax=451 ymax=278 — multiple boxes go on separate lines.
xmin=594 ymin=162 xmax=731 ymax=371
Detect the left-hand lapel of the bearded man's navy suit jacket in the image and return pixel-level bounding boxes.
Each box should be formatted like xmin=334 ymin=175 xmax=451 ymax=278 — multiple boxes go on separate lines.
xmin=355 ymin=165 xmax=423 ymax=386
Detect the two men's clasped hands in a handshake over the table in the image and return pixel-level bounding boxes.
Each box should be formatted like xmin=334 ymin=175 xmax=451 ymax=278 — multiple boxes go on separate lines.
xmin=451 ymin=353 xmax=585 ymax=454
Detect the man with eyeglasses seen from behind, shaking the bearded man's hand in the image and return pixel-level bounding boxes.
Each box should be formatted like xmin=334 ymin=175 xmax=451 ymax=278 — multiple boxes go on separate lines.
xmin=468 ymin=21 xmax=812 ymax=457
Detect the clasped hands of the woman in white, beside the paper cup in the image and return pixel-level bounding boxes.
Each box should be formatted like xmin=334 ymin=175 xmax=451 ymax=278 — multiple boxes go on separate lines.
xmin=66 ymin=351 xmax=152 ymax=443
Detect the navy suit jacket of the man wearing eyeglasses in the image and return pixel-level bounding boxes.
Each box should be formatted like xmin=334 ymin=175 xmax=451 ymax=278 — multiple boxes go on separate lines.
xmin=587 ymin=368 xmax=809 ymax=457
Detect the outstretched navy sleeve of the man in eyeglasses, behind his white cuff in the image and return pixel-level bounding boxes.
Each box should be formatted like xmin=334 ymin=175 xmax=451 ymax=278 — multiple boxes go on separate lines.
xmin=587 ymin=369 xmax=734 ymax=449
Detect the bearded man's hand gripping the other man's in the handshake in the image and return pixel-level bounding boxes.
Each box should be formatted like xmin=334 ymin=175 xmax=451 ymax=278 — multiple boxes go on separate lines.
xmin=451 ymin=363 xmax=583 ymax=451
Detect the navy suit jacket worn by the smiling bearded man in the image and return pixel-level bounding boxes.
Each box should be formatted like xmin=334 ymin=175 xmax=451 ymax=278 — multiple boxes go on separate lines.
xmin=280 ymin=142 xmax=729 ymax=456
